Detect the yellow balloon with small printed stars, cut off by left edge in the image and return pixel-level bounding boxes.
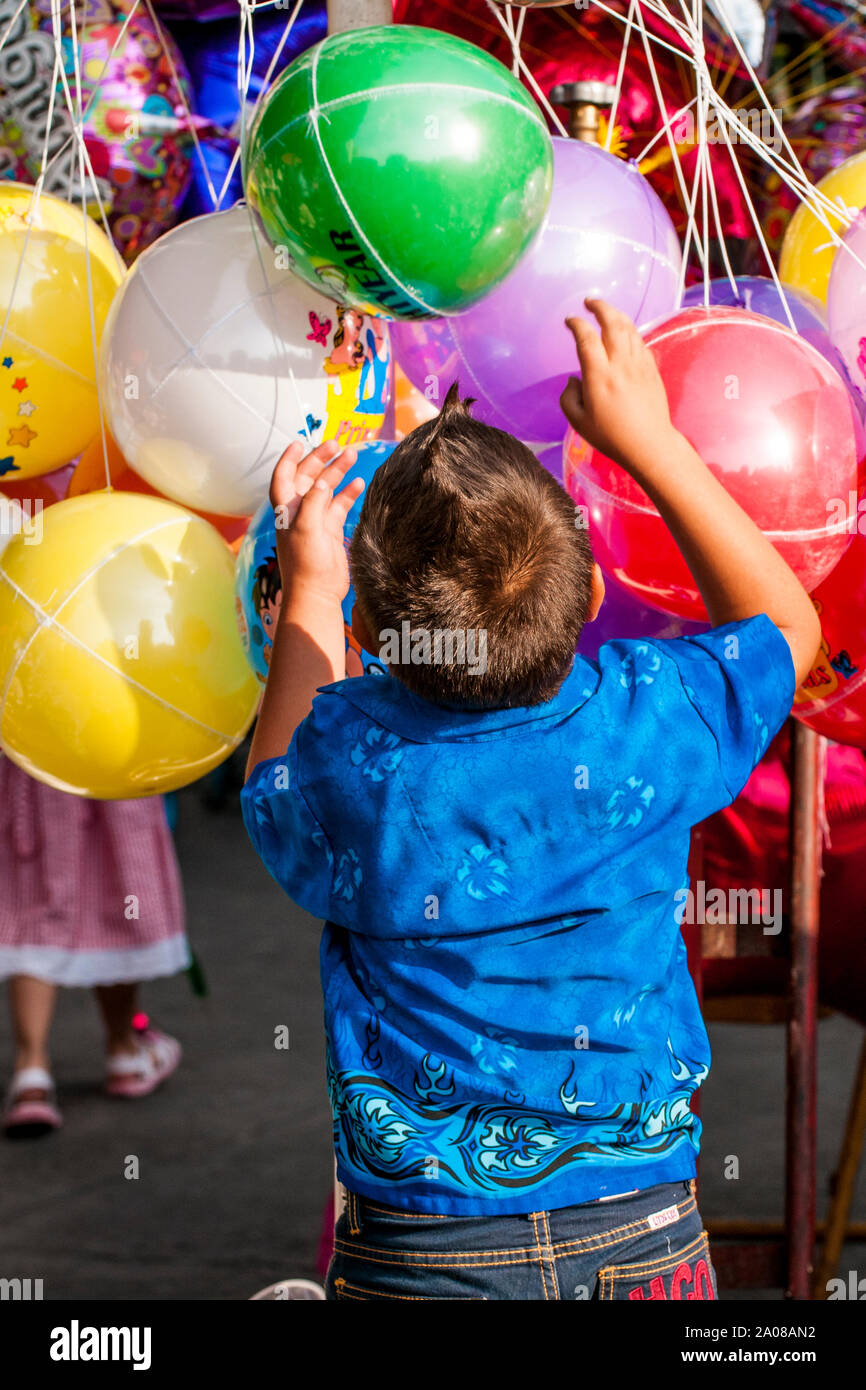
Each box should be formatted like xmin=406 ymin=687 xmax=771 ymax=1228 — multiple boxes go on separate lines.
xmin=0 ymin=183 xmax=124 ymax=478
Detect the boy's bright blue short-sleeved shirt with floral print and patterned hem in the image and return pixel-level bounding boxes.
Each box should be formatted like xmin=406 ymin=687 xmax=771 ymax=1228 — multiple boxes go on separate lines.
xmin=243 ymin=614 xmax=794 ymax=1215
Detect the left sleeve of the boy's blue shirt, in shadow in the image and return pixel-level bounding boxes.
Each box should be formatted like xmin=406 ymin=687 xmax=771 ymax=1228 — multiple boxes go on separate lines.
xmin=240 ymin=716 xmax=334 ymax=919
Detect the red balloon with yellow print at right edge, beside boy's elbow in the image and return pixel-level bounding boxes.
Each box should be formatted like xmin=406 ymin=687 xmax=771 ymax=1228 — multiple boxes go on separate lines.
xmin=794 ymin=492 xmax=866 ymax=748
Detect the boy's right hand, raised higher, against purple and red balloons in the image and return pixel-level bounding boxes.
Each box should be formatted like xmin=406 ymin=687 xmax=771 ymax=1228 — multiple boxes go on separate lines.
xmin=560 ymin=299 xmax=676 ymax=471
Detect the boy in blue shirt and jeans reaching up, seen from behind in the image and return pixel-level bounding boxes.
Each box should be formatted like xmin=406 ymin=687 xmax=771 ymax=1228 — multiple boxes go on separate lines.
xmin=243 ymin=300 xmax=820 ymax=1300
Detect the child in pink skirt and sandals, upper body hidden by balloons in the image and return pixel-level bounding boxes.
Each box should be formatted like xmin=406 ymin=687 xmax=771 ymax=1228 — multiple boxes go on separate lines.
xmin=0 ymin=755 xmax=190 ymax=1138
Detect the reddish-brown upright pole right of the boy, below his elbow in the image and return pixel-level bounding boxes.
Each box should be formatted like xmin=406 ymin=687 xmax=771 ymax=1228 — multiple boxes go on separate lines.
xmin=785 ymin=720 xmax=823 ymax=1298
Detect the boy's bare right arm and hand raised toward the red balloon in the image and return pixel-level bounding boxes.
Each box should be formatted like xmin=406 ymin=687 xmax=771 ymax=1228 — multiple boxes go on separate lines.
xmin=562 ymin=299 xmax=822 ymax=685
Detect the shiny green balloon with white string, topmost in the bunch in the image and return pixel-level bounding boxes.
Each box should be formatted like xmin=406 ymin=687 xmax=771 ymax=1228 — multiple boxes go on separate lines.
xmin=245 ymin=25 xmax=553 ymax=318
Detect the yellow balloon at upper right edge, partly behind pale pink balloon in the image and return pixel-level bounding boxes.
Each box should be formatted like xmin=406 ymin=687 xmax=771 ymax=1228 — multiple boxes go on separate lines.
xmin=778 ymin=152 xmax=866 ymax=303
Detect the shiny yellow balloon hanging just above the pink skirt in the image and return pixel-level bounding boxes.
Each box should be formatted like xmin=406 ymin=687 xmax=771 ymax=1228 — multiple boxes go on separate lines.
xmin=0 ymin=492 xmax=260 ymax=801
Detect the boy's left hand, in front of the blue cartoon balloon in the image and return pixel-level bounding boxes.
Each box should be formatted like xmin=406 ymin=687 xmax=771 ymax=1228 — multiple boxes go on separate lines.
xmin=270 ymin=441 xmax=364 ymax=603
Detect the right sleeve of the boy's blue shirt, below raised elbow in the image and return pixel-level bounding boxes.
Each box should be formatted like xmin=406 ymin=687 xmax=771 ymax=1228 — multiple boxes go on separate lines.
xmin=652 ymin=613 xmax=795 ymax=815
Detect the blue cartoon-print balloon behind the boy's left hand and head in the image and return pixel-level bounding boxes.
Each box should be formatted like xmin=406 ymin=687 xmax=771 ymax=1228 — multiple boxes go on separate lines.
xmin=235 ymin=439 xmax=396 ymax=684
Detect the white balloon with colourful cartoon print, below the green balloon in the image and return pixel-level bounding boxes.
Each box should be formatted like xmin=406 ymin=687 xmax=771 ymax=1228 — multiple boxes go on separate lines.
xmin=100 ymin=206 xmax=392 ymax=516
